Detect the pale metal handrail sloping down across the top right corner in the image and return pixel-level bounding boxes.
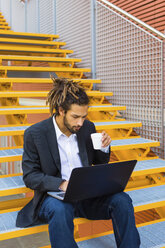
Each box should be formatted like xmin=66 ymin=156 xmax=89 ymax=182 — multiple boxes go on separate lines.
xmin=99 ymin=0 xmax=165 ymax=39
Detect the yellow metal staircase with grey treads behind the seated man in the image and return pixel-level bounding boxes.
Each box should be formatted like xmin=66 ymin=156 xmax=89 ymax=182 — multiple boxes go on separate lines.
xmin=0 ymin=11 xmax=165 ymax=248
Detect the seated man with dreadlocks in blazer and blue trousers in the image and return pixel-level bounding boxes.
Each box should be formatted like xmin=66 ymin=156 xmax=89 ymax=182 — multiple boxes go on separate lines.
xmin=17 ymin=78 xmax=140 ymax=248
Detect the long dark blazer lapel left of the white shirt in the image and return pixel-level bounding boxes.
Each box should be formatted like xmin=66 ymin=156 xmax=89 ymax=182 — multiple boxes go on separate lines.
xmin=46 ymin=117 xmax=61 ymax=171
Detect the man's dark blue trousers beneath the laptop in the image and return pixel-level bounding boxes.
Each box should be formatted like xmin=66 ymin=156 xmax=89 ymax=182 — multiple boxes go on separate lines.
xmin=39 ymin=192 xmax=140 ymax=248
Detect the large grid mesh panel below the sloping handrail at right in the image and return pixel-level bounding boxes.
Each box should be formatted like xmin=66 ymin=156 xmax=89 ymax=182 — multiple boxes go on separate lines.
xmin=96 ymin=2 xmax=163 ymax=157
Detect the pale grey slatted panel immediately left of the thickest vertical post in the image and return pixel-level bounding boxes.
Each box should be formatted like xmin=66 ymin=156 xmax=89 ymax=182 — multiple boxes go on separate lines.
xmin=56 ymin=0 xmax=91 ymax=68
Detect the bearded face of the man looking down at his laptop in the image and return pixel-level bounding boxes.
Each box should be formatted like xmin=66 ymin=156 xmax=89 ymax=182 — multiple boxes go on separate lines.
xmin=63 ymin=104 xmax=88 ymax=133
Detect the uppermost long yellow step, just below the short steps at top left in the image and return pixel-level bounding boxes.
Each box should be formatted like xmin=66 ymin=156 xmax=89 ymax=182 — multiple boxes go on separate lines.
xmin=0 ymin=30 xmax=59 ymax=40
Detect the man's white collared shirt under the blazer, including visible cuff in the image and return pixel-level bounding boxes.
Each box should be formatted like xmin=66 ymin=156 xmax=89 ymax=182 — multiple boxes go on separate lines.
xmin=53 ymin=116 xmax=109 ymax=181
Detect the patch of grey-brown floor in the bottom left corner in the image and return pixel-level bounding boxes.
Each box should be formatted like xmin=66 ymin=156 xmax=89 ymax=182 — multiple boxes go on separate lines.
xmin=0 ymin=232 xmax=50 ymax=248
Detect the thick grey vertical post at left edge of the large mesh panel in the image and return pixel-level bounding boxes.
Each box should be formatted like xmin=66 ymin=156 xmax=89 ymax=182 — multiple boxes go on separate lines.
xmin=91 ymin=0 xmax=96 ymax=89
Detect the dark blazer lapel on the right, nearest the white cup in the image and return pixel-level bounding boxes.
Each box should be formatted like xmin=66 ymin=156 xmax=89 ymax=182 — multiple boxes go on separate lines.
xmin=77 ymin=130 xmax=89 ymax=166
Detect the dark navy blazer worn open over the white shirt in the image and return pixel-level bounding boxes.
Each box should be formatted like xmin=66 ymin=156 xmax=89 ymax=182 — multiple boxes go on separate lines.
xmin=16 ymin=117 xmax=110 ymax=227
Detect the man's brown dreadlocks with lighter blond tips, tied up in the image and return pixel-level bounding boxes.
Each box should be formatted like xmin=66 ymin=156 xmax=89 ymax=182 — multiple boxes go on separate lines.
xmin=46 ymin=76 xmax=89 ymax=115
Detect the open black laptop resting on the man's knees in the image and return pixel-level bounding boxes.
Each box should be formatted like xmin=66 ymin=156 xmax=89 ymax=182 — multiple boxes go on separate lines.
xmin=47 ymin=160 xmax=137 ymax=202
